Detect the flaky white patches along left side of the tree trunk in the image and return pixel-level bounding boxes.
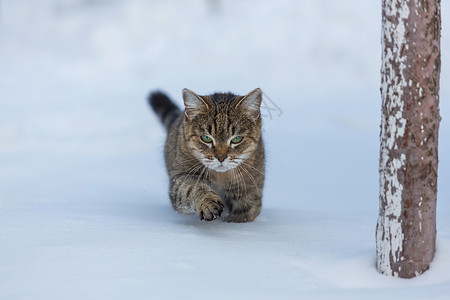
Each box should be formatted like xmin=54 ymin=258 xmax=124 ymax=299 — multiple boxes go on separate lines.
xmin=376 ymin=0 xmax=410 ymax=276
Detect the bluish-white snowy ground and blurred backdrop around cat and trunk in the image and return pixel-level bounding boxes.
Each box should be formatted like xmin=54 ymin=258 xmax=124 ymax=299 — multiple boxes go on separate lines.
xmin=0 ymin=0 xmax=450 ymax=299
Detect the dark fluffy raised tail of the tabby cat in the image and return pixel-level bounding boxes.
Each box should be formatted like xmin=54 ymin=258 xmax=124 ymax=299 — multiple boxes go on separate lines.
xmin=148 ymin=91 xmax=181 ymax=130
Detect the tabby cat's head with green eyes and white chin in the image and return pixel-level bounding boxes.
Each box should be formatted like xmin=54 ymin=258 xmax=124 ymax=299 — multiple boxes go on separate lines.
xmin=183 ymin=89 xmax=262 ymax=172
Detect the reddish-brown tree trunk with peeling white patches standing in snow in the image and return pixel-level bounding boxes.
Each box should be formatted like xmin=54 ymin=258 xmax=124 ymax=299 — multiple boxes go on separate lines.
xmin=376 ymin=0 xmax=441 ymax=278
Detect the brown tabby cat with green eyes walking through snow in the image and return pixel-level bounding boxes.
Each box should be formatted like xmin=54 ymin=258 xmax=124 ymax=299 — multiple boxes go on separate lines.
xmin=148 ymin=88 xmax=265 ymax=223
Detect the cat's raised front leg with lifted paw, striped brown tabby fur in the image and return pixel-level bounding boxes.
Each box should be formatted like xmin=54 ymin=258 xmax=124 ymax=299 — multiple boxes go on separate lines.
xmin=169 ymin=176 xmax=224 ymax=221
